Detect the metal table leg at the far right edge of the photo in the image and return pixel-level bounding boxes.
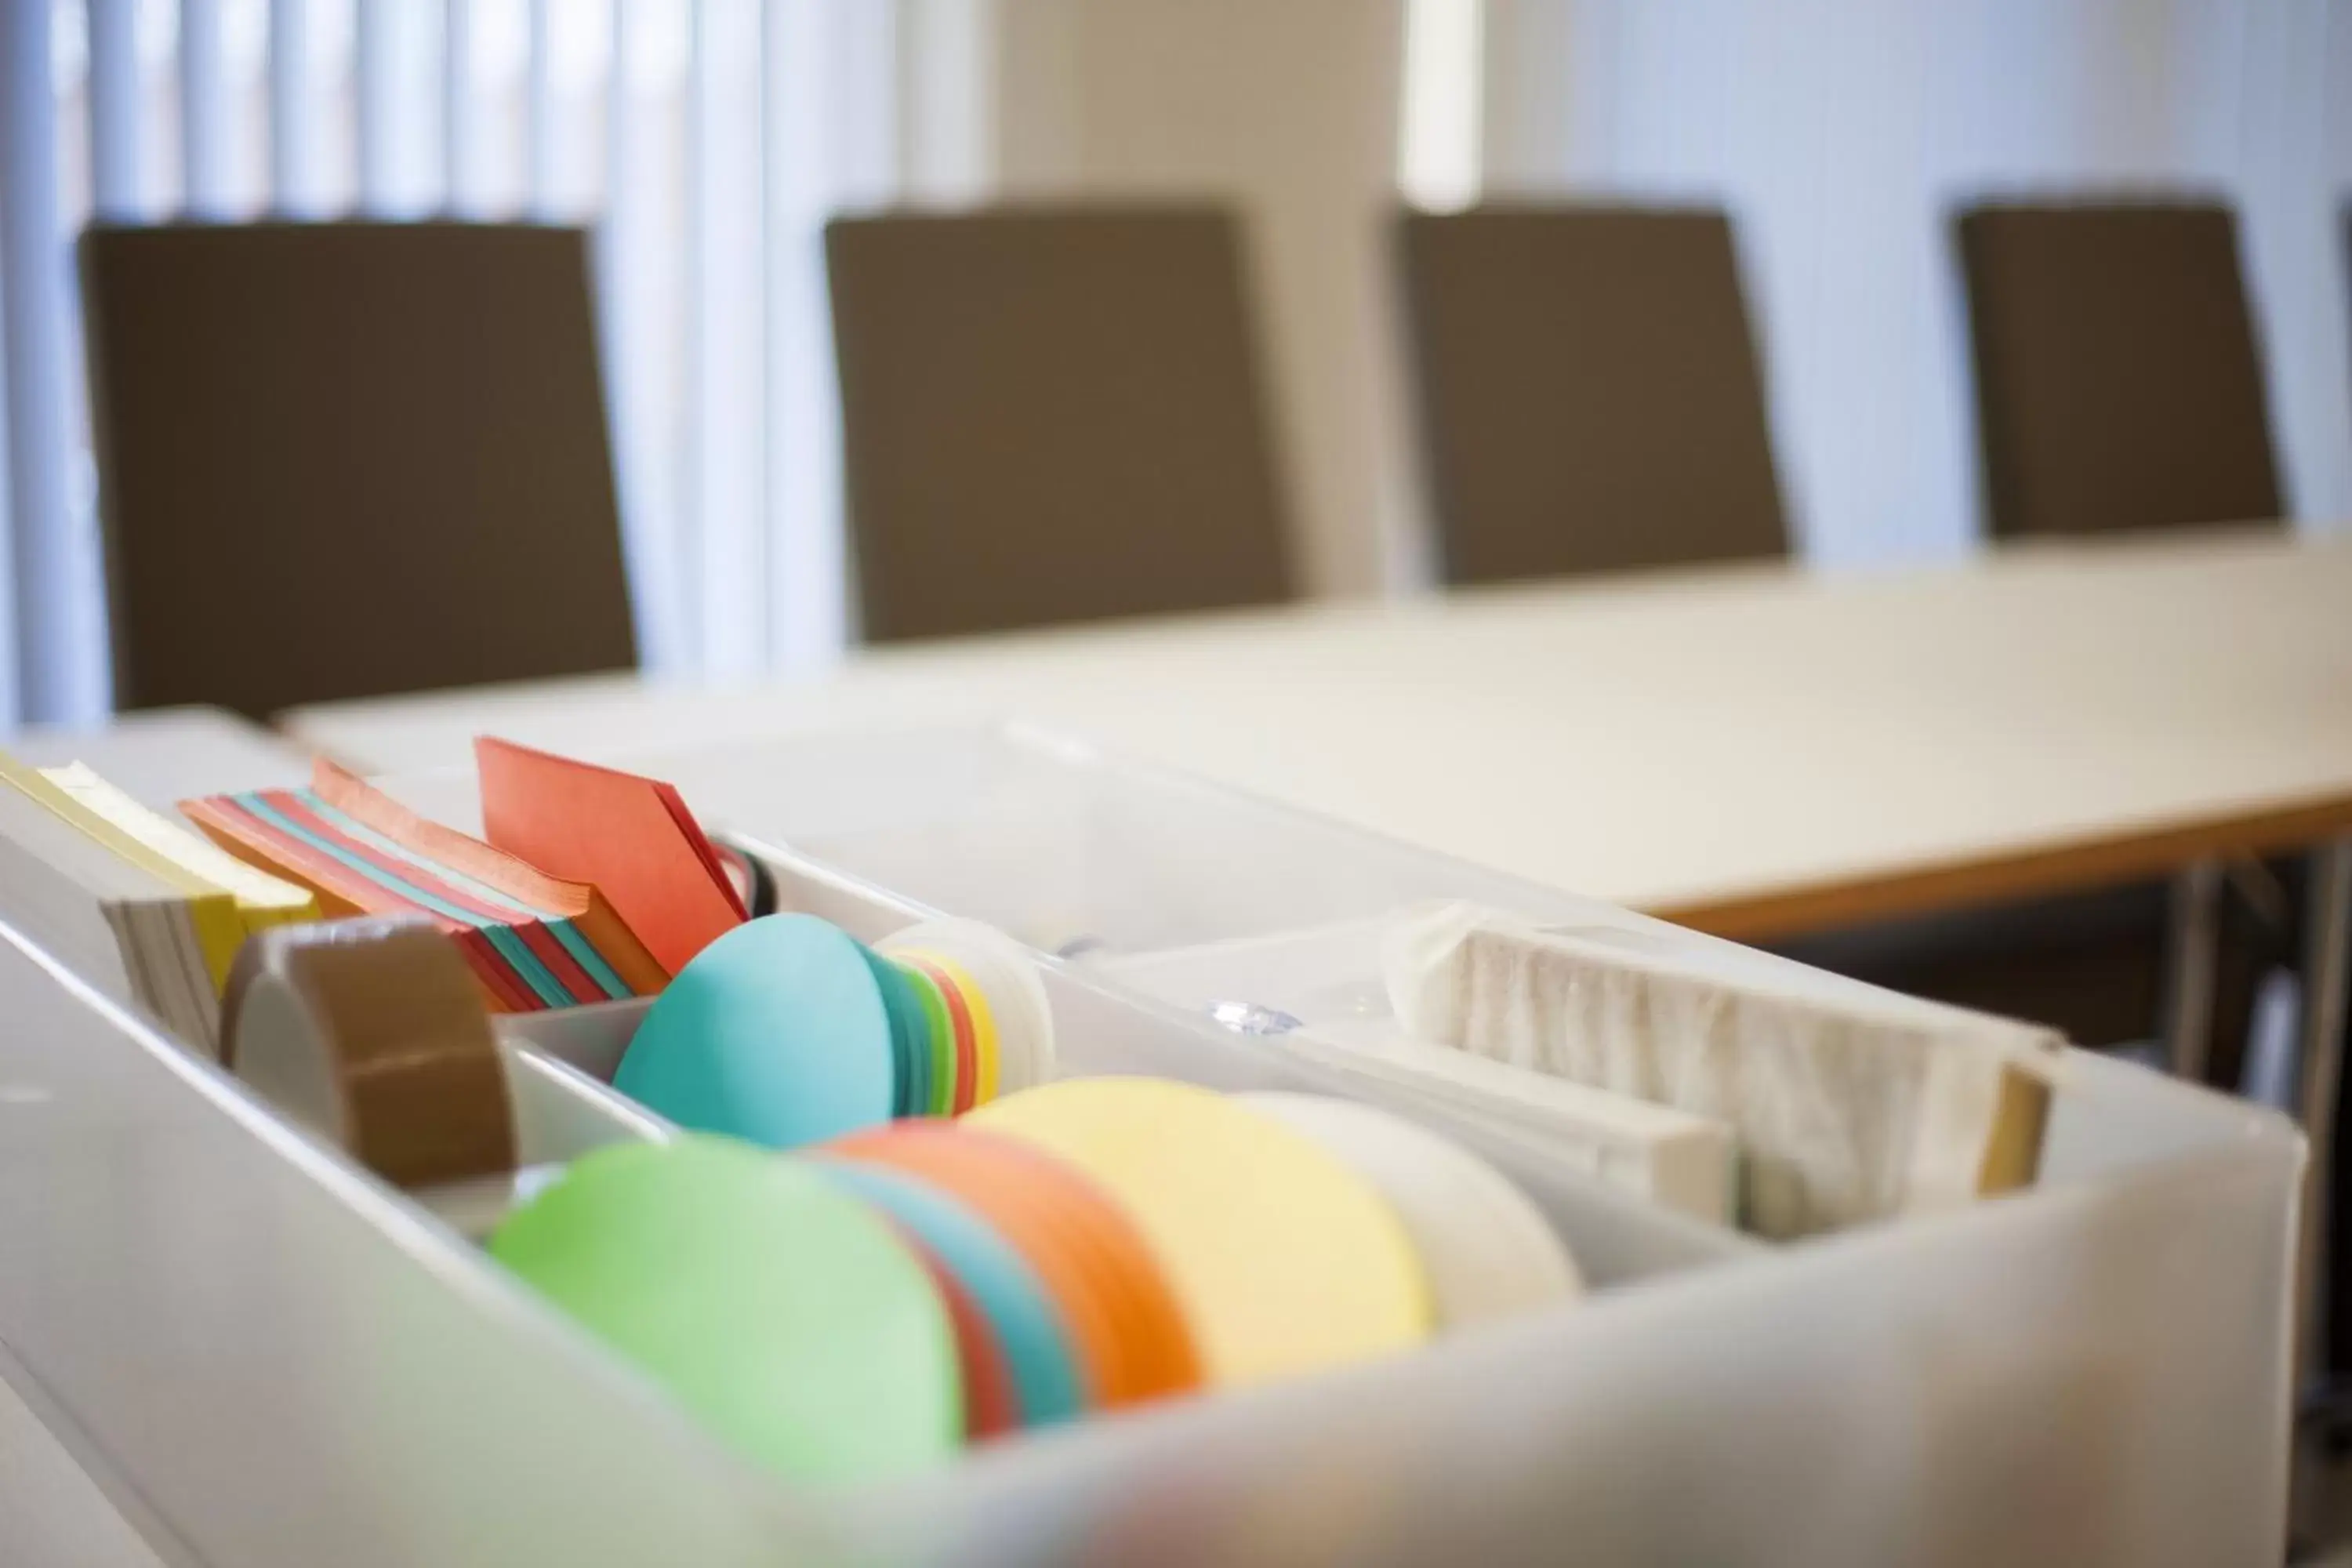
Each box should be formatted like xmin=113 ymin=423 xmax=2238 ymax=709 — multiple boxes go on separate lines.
xmin=2296 ymin=839 xmax=2352 ymax=1380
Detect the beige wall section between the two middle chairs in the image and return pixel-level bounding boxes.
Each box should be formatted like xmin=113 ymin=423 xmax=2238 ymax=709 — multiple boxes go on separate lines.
xmin=995 ymin=0 xmax=1409 ymax=595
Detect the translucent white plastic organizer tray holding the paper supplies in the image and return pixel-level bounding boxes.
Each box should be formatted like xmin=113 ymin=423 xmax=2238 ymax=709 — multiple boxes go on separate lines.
xmin=0 ymin=731 xmax=2303 ymax=1568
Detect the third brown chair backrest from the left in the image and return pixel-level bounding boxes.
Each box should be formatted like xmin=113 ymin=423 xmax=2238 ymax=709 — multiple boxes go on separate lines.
xmin=1399 ymin=205 xmax=1788 ymax=583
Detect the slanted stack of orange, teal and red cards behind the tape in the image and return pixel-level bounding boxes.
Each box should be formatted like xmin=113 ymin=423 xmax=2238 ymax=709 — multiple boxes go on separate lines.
xmin=181 ymin=760 xmax=670 ymax=1013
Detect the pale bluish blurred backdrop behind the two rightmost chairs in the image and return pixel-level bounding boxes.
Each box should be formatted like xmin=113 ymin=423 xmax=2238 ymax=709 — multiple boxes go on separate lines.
xmin=1484 ymin=0 xmax=2352 ymax=564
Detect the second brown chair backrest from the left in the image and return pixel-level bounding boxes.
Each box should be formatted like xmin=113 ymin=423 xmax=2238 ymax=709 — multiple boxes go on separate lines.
xmin=826 ymin=207 xmax=1291 ymax=642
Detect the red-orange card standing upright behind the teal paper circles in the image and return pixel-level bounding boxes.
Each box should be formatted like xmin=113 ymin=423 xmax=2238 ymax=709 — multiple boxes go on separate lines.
xmin=473 ymin=736 xmax=750 ymax=975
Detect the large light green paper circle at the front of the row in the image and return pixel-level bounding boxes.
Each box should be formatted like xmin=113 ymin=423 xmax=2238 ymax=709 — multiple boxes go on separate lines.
xmin=489 ymin=1138 xmax=964 ymax=1481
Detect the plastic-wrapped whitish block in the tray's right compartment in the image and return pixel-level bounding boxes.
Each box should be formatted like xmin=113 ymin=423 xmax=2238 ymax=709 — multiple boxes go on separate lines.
xmin=1385 ymin=905 xmax=2063 ymax=1239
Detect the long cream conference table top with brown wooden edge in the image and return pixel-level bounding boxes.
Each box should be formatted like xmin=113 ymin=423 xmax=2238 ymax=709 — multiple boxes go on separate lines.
xmin=282 ymin=532 xmax=2352 ymax=940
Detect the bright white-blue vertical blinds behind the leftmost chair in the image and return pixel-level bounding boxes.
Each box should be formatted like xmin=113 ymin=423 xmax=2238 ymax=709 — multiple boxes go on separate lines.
xmin=0 ymin=0 xmax=955 ymax=724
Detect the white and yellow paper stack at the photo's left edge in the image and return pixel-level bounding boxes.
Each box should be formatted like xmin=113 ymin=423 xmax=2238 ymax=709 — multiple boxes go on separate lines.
xmin=0 ymin=755 xmax=318 ymax=1053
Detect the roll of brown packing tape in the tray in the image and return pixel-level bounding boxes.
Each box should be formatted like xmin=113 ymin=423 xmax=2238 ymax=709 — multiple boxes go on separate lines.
xmin=221 ymin=916 xmax=515 ymax=1187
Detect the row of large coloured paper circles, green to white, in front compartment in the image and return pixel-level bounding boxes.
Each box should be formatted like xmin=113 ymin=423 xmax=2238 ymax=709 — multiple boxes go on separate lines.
xmin=489 ymin=1079 xmax=1581 ymax=1481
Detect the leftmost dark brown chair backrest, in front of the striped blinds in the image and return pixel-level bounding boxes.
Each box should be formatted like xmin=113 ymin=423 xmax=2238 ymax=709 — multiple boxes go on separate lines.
xmin=82 ymin=223 xmax=635 ymax=717
